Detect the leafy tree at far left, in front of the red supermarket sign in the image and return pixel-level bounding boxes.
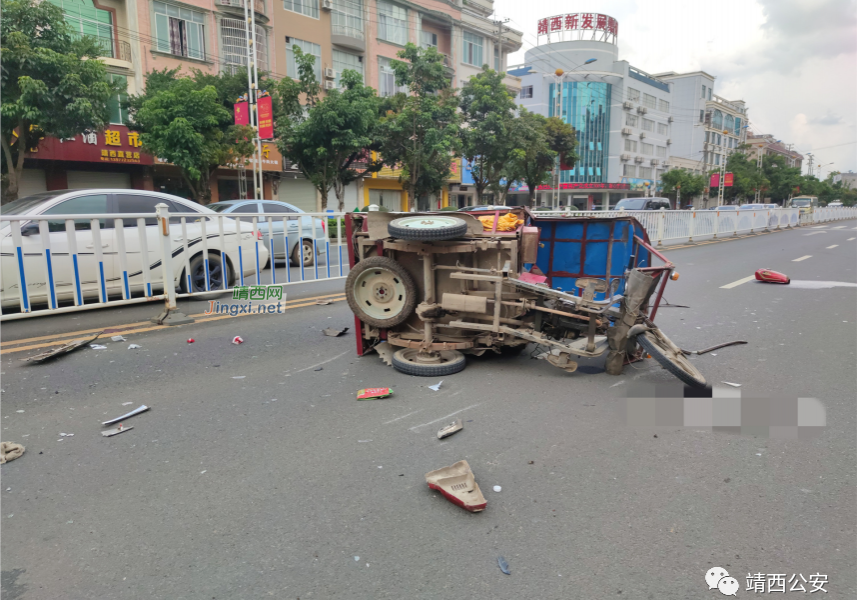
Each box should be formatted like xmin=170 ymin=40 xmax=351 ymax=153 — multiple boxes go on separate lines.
xmin=0 ymin=0 xmax=125 ymax=203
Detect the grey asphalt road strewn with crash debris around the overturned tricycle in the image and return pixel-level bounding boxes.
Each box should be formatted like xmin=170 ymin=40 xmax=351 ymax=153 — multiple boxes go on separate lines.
xmin=0 ymin=221 xmax=857 ymax=600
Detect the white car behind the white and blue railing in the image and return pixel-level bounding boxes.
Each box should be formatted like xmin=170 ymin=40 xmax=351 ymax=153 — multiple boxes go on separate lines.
xmin=0 ymin=189 xmax=268 ymax=307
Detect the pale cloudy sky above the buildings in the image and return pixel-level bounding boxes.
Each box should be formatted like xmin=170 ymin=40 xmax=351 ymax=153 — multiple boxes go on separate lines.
xmin=494 ymin=0 xmax=857 ymax=177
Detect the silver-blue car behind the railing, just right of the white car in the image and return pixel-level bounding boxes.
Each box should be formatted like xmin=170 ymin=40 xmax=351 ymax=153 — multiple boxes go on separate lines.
xmin=208 ymin=200 xmax=326 ymax=268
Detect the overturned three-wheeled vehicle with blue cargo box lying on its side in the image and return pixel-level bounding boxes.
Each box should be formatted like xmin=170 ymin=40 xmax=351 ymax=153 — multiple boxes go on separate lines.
xmin=345 ymin=208 xmax=706 ymax=387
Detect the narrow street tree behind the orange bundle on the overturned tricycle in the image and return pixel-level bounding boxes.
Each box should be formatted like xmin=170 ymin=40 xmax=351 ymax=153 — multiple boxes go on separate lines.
xmin=459 ymin=65 xmax=518 ymax=204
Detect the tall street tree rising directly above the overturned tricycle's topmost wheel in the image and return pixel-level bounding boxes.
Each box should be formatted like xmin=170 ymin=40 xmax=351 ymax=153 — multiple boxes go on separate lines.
xmin=381 ymin=44 xmax=460 ymax=206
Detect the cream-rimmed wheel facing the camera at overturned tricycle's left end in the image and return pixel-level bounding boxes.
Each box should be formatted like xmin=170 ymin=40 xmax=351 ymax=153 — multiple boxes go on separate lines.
xmin=345 ymin=256 xmax=417 ymax=329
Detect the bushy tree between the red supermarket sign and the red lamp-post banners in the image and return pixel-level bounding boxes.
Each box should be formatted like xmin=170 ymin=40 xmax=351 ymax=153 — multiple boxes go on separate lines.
xmin=127 ymin=70 xmax=254 ymax=204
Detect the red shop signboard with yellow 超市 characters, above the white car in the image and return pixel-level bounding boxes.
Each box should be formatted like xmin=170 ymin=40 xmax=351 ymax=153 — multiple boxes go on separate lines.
xmin=28 ymin=125 xmax=155 ymax=165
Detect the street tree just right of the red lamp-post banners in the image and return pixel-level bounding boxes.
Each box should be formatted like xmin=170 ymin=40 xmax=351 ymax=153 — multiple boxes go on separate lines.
xmin=277 ymin=49 xmax=383 ymax=212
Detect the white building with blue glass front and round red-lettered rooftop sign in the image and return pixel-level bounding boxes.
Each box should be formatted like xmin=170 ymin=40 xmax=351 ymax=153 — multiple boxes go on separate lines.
xmin=508 ymin=13 xmax=674 ymax=210
